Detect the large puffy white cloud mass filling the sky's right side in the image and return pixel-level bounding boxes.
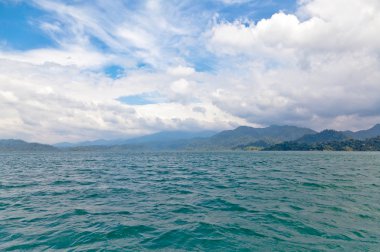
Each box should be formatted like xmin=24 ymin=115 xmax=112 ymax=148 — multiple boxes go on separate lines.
xmin=209 ymin=0 xmax=380 ymax=128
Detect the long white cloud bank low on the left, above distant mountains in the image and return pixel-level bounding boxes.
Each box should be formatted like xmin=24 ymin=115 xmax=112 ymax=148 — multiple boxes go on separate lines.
xmin=0 ymin=57 xmax=247 ymax=143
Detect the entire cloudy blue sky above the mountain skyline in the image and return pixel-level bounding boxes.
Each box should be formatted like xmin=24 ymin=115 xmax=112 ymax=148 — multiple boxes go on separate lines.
xmin=0 ymin=0 xmax=380 ymax=143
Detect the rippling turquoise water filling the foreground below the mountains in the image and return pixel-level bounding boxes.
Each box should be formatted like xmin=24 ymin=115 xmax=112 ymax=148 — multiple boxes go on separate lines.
xmin=0 ymin=152 xmax=380 ymax=251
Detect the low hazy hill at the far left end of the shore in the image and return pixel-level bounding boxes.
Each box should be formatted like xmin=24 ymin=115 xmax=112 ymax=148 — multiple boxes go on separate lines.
xmin=0 ymin=139 xmax=57 ymax=151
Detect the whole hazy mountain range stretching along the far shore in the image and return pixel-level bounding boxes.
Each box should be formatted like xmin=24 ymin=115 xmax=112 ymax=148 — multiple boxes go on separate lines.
xmin=0 ymin=124 xmax=380 ymax=151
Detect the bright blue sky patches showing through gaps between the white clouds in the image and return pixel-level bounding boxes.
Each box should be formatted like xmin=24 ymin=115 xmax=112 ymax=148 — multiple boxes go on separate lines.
xmin=0 ymin=0 xmax=296 ymax=78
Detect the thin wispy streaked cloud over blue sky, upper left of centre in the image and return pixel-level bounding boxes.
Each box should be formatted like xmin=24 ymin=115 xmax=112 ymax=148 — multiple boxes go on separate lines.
xmin=30 ymin=0 xmax=190 ymax=68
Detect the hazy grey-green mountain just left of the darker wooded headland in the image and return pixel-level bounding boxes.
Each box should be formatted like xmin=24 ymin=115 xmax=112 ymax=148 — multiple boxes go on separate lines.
xmin=189 ymin=125 xmax=316 ymax=149
